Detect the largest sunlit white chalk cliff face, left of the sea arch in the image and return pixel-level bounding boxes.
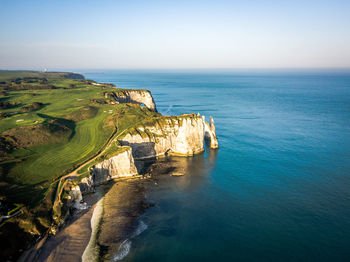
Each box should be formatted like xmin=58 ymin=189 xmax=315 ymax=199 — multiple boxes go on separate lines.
xmin=119 ymin=114 xmax=204 ymax=159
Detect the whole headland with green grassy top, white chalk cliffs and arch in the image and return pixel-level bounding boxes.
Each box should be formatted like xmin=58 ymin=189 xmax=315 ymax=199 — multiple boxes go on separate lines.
xmin=0 ymin=71 xmax=218 ymax=261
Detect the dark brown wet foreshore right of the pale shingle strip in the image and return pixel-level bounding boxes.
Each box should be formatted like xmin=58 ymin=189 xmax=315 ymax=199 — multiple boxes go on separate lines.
xmin=90 ymin=179 xmax=147 ymax=261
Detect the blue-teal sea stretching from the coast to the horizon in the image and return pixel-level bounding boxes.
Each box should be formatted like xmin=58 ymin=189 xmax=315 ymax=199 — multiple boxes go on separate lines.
xmin=85 ymin=71 xmax=350 ymax=262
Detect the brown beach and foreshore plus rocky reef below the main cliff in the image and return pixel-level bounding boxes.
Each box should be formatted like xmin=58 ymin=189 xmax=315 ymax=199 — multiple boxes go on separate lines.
xmin=20 ymin=152 xmax=215 ymax=262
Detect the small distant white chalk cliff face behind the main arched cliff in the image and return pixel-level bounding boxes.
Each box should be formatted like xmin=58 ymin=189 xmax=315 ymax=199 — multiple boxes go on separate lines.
xmin=113 ymin=89 xmax=157 ymax=112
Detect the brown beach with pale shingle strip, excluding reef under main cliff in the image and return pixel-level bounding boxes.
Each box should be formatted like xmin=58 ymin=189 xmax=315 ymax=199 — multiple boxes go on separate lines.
xmin=22 ymin=176 xmax=150 ymax=262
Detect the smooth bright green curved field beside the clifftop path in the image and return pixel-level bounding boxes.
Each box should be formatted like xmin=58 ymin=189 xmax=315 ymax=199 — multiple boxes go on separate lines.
xmin=8 ymin=108 xmax=113 ymax=184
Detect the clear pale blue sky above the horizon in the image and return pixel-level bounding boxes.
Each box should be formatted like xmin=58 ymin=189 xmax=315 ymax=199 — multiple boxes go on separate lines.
xmin=0 ymin=0 xmax=350 ymax=69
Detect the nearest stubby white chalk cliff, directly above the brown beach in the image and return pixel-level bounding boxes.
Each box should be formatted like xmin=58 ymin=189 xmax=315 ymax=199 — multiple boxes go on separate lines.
xmin=92 ymin=147 xmax=137 ymax=185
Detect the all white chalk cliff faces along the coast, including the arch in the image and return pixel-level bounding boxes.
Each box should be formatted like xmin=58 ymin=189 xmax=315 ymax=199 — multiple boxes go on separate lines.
xmin=79 ymin=90 xmax=218 ymax=190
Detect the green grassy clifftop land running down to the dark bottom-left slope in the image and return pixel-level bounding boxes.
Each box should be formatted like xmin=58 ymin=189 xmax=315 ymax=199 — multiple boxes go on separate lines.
xmin=0 ymin=71 xmax=159 ymax=259
